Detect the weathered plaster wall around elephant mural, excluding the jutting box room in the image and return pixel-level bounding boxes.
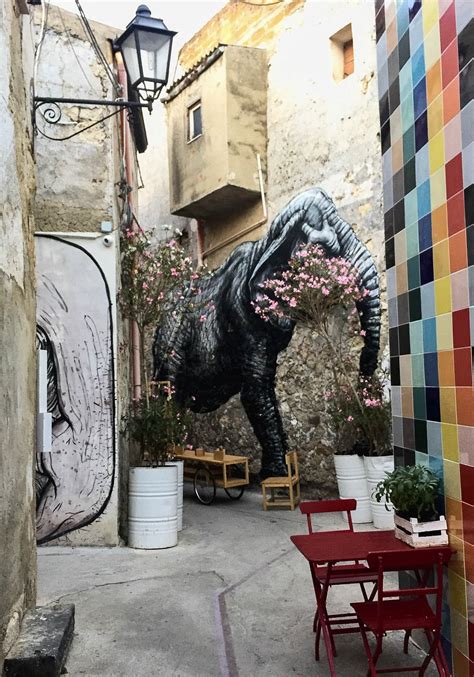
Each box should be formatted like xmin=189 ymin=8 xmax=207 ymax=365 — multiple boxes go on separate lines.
xmin=181 ymin=0 xmax=386 ymax=488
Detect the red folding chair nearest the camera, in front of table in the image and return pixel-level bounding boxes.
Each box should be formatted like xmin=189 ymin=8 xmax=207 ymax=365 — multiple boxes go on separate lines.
xmin=351 ymin=546 xmax=451 ymax=677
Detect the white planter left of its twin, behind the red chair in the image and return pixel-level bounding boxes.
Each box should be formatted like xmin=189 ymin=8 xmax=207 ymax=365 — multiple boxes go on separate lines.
xmin=334 ymin=454 xmax=372 ymax=524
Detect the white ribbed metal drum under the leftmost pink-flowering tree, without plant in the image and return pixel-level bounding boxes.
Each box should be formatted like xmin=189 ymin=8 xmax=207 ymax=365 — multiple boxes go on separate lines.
xmin=128 ymin=465 xmax=178 ymax=550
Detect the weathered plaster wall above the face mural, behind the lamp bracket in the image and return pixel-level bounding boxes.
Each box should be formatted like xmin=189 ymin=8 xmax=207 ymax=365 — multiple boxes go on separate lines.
xmin=35 ymin=6 xmax=119 ymax=231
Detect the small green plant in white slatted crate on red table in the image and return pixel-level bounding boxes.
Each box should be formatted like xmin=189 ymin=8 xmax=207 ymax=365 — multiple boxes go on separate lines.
xmin=374 ymin=464 xmax=448 ymax=547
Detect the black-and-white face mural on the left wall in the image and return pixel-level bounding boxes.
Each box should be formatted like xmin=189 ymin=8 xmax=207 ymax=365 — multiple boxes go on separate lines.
xmin=36 ymin=235 xmax=115 ymax=543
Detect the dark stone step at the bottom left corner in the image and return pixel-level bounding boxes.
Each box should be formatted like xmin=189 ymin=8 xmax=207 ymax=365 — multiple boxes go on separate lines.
xmin=4 ymin=604 xmax=74 ymax=677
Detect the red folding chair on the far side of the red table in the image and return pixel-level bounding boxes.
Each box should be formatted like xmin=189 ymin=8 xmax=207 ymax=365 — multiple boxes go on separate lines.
xmin=300 ymin=498 xmax=377 ymax=661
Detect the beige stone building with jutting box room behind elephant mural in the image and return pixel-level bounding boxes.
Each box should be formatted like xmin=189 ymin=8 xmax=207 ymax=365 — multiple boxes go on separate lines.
xmin=158 ymin=0 xmax=386 ymax=493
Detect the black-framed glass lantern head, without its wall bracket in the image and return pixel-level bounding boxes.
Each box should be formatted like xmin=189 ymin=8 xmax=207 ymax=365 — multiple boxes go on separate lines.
xmin=115 ymin=5 xmax=176 ymax=104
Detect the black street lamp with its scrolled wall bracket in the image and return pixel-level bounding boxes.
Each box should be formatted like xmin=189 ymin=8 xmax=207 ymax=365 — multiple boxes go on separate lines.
xmin=33 ymin=5 xmax=176 ymax=141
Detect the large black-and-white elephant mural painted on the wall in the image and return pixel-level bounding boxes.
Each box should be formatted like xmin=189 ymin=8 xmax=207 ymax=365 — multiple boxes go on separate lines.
xmin=153 ymin=188 xmax=380 ymax=479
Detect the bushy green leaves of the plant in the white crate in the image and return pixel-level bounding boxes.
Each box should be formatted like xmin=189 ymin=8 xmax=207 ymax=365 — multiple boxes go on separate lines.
xmin=374 ymin=465 xmax=440 ymax=521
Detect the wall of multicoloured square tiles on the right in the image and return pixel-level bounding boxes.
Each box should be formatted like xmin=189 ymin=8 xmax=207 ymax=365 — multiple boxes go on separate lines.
xmin=376 ymin=0 xmax=474 ymax=677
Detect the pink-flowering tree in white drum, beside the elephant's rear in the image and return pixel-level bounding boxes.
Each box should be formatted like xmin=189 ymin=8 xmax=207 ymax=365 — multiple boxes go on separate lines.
xmin=119 ymin=229 xmax=198 ymax=548
